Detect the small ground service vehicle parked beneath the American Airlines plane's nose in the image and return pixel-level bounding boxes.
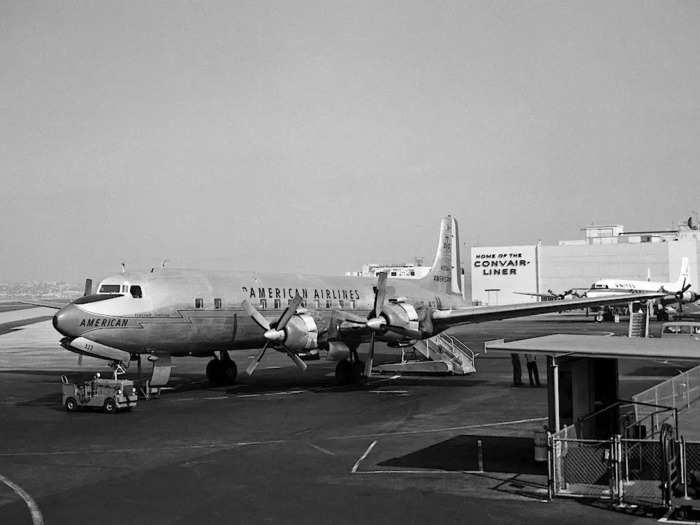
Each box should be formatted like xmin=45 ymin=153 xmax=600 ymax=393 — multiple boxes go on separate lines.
xmin=61 ymin=376 xmax=138 ymax=414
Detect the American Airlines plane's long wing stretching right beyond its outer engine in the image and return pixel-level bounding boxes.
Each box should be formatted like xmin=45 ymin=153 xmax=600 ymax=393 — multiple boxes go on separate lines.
xmin=433 ymin=292 xmax=664 ymax=330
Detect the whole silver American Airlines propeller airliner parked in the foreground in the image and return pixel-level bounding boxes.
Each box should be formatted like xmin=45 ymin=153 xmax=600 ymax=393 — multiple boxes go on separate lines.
xmin=38 ymin=216 xmax=661 ymax=384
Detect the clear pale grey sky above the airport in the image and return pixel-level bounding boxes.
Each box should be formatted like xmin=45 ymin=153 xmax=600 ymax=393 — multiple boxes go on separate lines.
xmin=0 ymin=0 xmax=700 ymax=281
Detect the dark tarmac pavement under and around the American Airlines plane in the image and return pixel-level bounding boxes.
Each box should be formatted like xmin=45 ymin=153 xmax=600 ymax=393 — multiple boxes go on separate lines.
xmin=0 ymin=304 xmax=688 ymax=525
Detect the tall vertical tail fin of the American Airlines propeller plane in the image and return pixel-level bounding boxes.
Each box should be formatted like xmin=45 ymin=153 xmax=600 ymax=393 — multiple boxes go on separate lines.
xmin=420 ymin=215 xmax=462 ymax=296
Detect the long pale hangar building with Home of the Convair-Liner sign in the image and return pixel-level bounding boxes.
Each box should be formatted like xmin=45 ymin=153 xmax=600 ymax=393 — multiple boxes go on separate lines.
xmin=465 ymin=219 xmax=700 ymax=305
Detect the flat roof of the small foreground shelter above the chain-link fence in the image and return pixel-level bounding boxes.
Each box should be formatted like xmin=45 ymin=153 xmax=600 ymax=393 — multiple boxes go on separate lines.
xmin=484 ymin=334 xmax=700 ymax=361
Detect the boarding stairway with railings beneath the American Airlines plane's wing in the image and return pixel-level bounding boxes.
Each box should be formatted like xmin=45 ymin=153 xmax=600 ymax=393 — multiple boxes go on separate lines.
xmin=377 ymin=334 xmax=477 ymax=375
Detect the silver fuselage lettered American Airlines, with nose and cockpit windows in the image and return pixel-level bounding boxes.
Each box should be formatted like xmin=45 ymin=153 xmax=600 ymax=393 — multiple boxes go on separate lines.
xmin=54 ymin=268 xmax=463 ymax=356
